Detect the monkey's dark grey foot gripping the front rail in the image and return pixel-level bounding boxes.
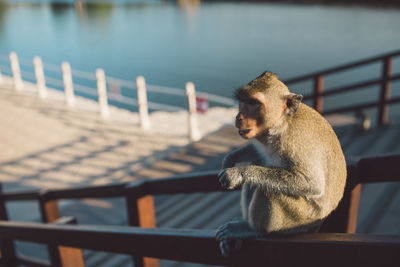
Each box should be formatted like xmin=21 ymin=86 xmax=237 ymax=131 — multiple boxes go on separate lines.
xmin=215 ymin=218 xmax=261 ymax=258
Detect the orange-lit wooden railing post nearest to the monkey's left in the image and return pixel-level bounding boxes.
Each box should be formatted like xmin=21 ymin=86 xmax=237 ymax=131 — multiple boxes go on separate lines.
xmin=125 ymin=185 xmax=160 ymax=267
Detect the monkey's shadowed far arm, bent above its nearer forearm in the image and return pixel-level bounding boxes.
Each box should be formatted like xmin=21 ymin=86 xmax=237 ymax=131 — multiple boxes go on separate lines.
xmin=222 ymin=143 xmax=262 ymax=169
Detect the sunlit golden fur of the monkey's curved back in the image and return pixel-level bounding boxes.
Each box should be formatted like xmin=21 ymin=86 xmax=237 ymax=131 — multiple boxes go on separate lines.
xmin=289 ymin=104 xmax=347 ymax=220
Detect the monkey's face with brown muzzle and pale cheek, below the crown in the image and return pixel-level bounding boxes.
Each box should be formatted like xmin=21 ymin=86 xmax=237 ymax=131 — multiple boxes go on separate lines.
xmin=236 ymin=92 xmax=282 ymax=139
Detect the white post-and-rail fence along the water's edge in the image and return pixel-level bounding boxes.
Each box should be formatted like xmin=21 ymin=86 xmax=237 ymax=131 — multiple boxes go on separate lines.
xmin=0 ymin=52 xmax=235 ymax=141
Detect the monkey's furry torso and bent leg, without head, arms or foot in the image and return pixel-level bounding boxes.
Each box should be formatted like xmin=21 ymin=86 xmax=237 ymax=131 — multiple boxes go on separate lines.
xmin=253 ymin=104 xmax=347 ymax=233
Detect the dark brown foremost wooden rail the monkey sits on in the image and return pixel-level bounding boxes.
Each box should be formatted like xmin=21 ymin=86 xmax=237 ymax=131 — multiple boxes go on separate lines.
xmin=0 ymin=222 xmax=400 ymax=267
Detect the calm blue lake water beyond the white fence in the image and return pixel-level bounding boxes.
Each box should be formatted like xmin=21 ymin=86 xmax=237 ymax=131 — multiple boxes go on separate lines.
xmin=0 ymin=1 xmax=400 ymax=118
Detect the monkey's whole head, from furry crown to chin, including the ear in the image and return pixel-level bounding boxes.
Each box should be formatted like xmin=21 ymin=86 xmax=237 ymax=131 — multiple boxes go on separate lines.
xmin=235 ymin=72 xmax=303 ymax=139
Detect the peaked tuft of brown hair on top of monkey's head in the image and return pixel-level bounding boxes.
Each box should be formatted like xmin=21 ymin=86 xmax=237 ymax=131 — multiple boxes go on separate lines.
xmin=235 ymin=71 xmax=290 ymax=100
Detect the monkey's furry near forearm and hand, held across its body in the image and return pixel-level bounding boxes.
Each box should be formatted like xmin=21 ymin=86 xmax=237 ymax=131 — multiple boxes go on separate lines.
xmin=218 ymin=165 xmax=324 ymax=196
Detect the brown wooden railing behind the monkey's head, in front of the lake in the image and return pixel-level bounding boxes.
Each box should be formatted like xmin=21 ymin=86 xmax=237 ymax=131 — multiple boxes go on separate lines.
xmin=285 ymin=51 xmax=400 ymax=125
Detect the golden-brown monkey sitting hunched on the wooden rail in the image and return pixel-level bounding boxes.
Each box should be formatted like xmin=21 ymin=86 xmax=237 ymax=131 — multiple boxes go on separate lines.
xmin=216 ymin=72 xmax=347 ymax=257
